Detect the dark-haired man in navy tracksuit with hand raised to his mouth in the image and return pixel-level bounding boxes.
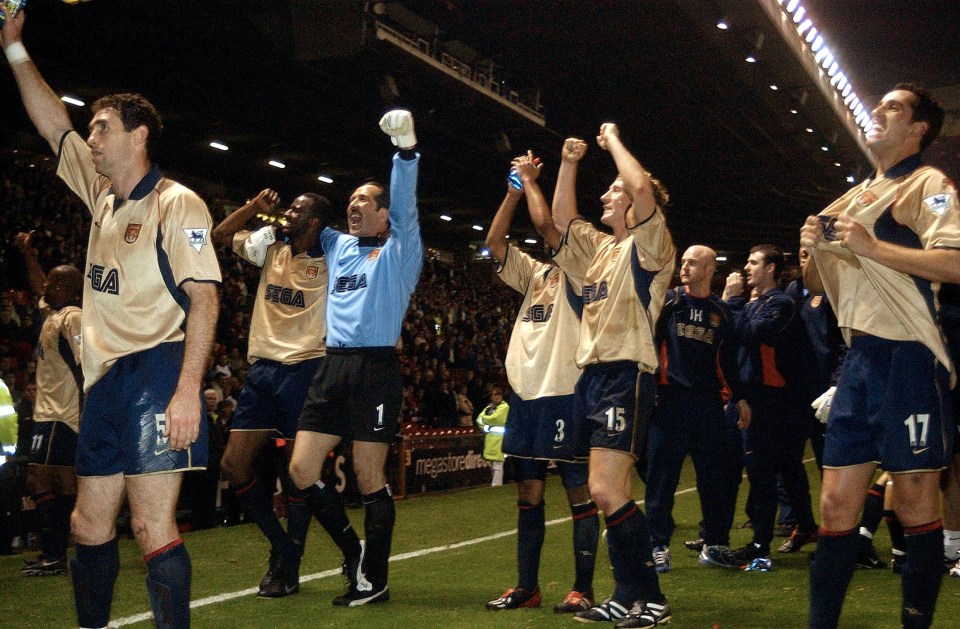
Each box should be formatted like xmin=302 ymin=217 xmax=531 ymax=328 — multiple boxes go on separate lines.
xmin=704 ymin=245 xmax=813 ymax=567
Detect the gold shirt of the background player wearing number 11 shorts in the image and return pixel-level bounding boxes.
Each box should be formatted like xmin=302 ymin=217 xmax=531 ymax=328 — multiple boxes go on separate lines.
xmin=33 ymin=306 xmax=83 ymax=432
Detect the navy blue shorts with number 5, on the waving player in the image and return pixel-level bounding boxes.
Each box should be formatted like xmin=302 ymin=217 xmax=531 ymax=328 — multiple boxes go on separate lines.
xmin=77 ymin=343 xmax=207 ymax=476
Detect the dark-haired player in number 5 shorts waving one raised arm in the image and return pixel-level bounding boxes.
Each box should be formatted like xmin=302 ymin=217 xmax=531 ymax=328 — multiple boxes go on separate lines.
xmin=2 ymin=13 xmax=220 ymax=628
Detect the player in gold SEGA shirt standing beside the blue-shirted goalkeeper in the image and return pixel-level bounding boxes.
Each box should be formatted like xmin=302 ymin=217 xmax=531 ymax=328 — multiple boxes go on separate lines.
xmin=212 ymin=189 xmax=338 ymax=598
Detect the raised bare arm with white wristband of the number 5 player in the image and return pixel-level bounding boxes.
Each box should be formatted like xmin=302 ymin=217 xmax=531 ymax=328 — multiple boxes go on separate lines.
xmin=0 ymin=9 xmax=73 ymax=153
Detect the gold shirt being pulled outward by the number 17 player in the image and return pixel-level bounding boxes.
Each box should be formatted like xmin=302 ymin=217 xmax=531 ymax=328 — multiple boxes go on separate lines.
xmin=813 ymin=155 xmax=960 ymax=366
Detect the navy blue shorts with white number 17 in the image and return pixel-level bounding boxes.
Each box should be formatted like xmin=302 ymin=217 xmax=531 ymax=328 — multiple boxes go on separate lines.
xmin=823 ymin=336 xmax=955 ymax=473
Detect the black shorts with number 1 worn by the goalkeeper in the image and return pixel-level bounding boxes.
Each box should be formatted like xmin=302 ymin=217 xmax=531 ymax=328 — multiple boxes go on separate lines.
xmin=298 ymin=347 xmax=402 ymax=443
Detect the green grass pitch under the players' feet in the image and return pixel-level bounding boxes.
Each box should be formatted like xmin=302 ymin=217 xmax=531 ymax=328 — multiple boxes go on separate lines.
xmin=0 ymin=448 xmax=960 ymax=629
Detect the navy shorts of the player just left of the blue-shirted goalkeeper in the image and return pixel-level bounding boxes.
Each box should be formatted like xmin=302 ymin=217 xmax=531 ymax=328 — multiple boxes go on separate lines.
xmin=230 ymin=358 xmax=323 ymax=439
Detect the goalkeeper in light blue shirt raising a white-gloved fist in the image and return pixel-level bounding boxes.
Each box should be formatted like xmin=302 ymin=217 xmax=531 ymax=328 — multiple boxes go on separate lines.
xmin=290 ymin=110 xmax=423 ymax=607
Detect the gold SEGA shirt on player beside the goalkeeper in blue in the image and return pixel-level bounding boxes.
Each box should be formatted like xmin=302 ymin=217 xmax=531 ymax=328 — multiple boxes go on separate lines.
xmin=233 ymin=230 xmax=327 ymax=365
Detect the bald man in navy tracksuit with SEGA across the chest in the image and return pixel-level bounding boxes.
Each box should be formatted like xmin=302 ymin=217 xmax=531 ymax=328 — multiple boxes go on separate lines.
xmin=646 ymin=245 xmax=749 ymax=572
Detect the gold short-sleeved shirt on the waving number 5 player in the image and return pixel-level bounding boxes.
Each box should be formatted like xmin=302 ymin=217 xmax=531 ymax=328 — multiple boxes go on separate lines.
xmin=57 ymin=131 xmax=220 ymax=390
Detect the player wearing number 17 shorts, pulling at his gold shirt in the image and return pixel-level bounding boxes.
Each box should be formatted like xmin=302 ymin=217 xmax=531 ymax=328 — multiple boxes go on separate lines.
xmin=800 ymin=83 xmax=960 ymax=629
